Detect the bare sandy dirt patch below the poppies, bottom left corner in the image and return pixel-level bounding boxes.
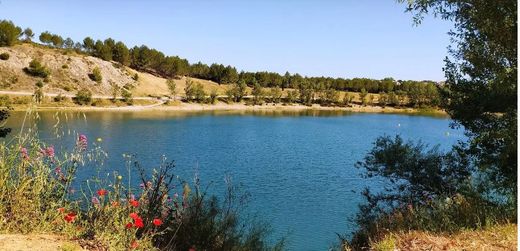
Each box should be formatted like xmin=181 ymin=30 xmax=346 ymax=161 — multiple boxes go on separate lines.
xmin=0 ymin=234 xmax=85 ymax=251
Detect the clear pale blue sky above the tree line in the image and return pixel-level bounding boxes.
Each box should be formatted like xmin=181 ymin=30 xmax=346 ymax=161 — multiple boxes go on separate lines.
xmin=0 ymin=0 xmax=452 ymax=80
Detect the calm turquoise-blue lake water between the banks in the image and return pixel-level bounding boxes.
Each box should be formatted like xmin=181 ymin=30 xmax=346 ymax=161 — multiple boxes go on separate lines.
xmin=8 ymin=111 xmax=463 ymax=250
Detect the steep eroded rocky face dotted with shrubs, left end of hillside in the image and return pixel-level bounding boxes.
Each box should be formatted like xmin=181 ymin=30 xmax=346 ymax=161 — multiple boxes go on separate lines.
xmin=0 ymin=44 xmax=137 ymax=95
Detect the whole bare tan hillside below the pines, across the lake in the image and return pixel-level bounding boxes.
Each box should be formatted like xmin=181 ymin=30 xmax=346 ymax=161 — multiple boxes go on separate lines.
xmin=0 ymin=43 xmax=224 ymax=96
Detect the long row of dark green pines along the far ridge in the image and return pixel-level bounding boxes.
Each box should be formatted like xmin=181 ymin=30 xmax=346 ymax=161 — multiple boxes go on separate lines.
xmin=0 ymin=20 xmax=439 ymax=106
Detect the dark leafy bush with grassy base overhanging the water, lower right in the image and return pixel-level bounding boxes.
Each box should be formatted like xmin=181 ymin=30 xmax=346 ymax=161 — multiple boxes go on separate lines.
xmin=346 ymin=136 xmax=516 ymax=248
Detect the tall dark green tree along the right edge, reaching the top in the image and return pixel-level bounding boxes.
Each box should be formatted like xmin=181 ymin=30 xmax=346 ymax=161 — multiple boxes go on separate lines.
xmin=402 ymin=0 xmax=518 ymax=196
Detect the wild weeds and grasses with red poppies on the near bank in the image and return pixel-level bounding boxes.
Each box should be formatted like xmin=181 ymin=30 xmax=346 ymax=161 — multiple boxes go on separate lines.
xmin=0 ymin=112 xmax=283 ymax=250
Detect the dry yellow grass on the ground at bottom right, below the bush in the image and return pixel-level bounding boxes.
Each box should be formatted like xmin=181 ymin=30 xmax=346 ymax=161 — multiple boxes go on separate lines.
xmin=371 ymin=224 xmax=518 ymax=251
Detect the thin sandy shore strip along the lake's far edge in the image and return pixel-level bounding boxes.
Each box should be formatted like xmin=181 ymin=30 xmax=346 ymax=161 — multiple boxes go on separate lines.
xmin=4 ymin=102 xmax=447 ymax=115
